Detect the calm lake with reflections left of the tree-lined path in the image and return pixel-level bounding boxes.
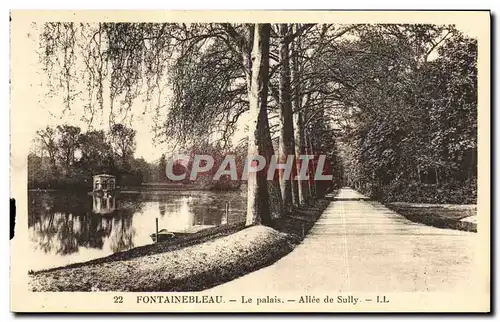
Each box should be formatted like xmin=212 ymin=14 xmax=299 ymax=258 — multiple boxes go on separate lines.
xmin=28 ymin=191 xmax=246 ymax=270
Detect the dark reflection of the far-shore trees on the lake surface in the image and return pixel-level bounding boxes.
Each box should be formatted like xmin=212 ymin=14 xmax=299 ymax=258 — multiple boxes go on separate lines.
xmin=28 ymin=193 xmax=141 ymax=255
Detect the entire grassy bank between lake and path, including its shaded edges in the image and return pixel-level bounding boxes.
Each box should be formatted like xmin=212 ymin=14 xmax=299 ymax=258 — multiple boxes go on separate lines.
xmin=29 ymin=196 xmax=329 ymax=291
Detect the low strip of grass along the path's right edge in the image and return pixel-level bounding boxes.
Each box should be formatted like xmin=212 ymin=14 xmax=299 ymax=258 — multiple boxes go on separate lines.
xmin=386 ymin=202 xmax=477 ymax=232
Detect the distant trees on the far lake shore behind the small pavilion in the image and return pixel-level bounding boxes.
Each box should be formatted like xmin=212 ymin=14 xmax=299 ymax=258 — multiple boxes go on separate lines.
xmin=28 ymin=124 xmax=155 ymax=188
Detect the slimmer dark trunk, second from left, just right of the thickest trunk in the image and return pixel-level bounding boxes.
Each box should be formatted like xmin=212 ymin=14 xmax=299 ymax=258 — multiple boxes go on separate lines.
xmin=278 ymin=24 xmax=299 ymax=213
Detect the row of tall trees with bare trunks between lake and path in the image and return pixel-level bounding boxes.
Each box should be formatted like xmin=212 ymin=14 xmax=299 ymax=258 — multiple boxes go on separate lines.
xmin=160 ymin=24 xmax=352 ymax=224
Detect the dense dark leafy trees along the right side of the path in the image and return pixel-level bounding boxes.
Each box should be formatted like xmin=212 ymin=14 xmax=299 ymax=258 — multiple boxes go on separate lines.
xmin=332 ymin=26 xmax=477 ymax=203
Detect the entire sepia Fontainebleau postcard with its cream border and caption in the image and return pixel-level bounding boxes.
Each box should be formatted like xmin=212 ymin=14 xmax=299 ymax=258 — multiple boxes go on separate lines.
xmin=10 ymin=11 xmax=491 ymax=312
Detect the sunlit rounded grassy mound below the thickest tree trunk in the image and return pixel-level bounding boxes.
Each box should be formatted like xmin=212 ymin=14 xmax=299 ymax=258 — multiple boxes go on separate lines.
xmin=30 ymin=226 xmax=297 ymax=292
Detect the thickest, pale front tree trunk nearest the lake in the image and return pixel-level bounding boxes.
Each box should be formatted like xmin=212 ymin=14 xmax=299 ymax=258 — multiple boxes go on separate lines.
xmin=246 ymin=24 xmax=271 ymax=226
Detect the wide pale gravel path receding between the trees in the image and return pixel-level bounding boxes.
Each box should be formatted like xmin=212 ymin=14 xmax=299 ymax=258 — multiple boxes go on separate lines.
xmin=212 ymin=189 xmax=478 ymax=294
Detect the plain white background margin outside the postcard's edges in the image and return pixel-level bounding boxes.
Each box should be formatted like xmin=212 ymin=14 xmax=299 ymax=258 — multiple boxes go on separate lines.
xmin=0 ymin=0 xmax=500 ymax=321
